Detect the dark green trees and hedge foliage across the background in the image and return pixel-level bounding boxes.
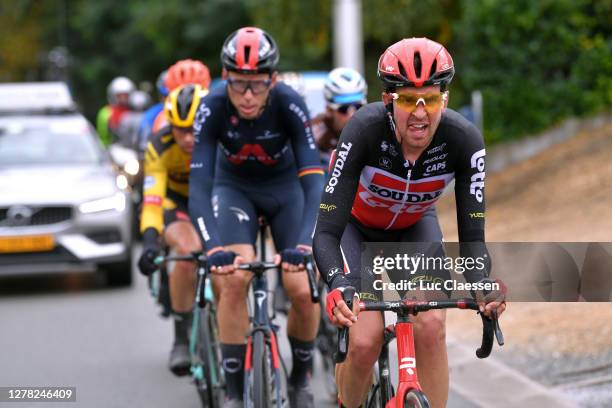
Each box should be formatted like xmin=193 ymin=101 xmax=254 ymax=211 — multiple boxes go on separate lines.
xmin=0 ymin=0 xmax=612 ymax=142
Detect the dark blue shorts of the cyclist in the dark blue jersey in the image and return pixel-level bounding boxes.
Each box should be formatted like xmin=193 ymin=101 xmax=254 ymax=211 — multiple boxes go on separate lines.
xmin=213 ymin=178 xmax=304 ymax=252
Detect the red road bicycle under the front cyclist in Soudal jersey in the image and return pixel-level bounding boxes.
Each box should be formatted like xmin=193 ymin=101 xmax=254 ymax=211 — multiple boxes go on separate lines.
xmin=336 ymin=288 xmax=504 ymax=408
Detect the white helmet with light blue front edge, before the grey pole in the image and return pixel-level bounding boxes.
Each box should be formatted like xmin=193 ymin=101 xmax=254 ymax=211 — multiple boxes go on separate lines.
xmin=323 ymin=68 xmax=368 ymax=105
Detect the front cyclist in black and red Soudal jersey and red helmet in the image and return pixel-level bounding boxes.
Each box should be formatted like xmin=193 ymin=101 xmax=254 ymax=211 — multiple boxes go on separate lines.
xmin=313 ymin=38 xmax=505 ymax=407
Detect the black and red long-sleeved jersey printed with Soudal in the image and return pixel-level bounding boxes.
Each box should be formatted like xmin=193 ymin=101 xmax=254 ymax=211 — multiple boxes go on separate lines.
xmin=313 ymin=102 xmax=486 ymax=287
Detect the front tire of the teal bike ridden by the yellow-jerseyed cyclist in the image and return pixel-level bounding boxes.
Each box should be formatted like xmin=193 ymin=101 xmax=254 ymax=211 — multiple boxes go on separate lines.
xmin=195 ymin=308 xmax=224 ymax=408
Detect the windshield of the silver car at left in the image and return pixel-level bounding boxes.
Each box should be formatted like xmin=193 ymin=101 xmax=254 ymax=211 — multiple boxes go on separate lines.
xmin=0 ymin=125 xmax=101 ymax=165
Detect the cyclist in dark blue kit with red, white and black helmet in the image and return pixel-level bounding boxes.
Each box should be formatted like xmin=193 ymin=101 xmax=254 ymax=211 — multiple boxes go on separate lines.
xmin=189 ymin=27 xmax=323 ymax=407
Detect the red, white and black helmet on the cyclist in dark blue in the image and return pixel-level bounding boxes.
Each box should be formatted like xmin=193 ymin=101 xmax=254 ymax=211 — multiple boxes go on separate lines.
xmin=221 ymin=27 xmax=279 ymax=74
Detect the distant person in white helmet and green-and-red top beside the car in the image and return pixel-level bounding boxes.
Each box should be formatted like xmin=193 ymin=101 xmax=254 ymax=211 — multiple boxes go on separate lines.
xmin=96 ymin=77 xmax=136 ymax=147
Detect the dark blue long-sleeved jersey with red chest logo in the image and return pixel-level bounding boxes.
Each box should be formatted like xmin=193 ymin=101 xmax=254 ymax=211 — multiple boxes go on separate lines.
xmin=189 ymin=83 xmax=323 ymax=250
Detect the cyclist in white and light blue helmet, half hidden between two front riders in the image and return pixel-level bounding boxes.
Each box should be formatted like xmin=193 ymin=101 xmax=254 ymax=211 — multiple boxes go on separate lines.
xmin=312 ymin=68 xmax=368 ymax=168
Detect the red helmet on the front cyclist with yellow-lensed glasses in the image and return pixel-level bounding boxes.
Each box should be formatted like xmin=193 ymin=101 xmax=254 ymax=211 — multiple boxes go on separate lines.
xmin=378 ymin=38 xmax=455 ymax=91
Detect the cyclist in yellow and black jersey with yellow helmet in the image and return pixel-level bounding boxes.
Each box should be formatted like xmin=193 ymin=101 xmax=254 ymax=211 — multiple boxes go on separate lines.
xmin=138 ymin=84 xmax=208 ymax=375
